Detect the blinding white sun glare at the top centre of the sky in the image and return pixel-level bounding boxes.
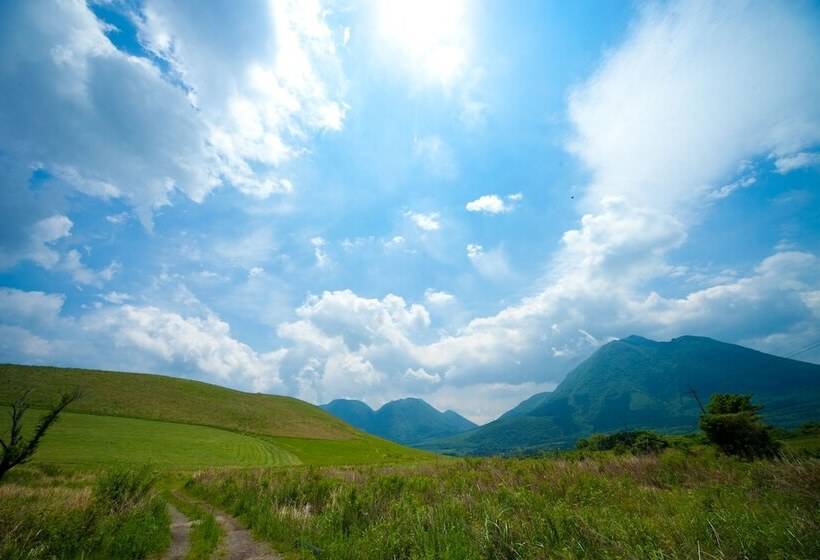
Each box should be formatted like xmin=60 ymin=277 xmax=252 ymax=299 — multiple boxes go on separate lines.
xmin=377 ymin=0 xmax=467 ymax=86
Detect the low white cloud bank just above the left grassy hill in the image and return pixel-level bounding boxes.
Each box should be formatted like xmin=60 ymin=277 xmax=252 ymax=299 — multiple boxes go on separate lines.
xmin=0 ymin=288 xmax=286 ymax=392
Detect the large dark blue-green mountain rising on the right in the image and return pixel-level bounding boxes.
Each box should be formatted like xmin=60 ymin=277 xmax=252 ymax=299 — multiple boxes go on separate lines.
xmin=424 ymin=336 xmax=820 ymax=454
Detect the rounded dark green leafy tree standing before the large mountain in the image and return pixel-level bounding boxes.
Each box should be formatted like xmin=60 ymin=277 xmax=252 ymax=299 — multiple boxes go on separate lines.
xmin=700 ymin=394 xmax=780 ymax=459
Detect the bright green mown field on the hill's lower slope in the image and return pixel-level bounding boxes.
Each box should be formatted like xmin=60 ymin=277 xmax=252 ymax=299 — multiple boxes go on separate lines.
xmin=0 ymin=407 xmax=433 ymax=470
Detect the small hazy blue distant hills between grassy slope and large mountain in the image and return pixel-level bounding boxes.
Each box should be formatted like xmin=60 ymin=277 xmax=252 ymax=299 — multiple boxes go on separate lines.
xmin=321 ymin=398 xmax=476 ymax=445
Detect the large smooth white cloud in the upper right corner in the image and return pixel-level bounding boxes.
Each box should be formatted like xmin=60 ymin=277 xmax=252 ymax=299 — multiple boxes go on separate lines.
xmin=569 ymin=1 xmax=820 ymax=214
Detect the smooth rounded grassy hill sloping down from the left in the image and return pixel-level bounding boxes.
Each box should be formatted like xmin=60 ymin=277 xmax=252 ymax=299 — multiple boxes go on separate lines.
xmin=0 ymin=365 xmax=430 ymax=469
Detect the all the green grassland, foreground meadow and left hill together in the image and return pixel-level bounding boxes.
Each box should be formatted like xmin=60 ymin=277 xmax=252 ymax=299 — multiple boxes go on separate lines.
xmin=0 ymin=366 xmax=820 ymax=560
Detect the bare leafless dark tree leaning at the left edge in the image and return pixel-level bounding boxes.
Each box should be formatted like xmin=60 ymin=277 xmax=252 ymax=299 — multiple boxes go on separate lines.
xmin=0 ymin=390 xmax=81 ymax=481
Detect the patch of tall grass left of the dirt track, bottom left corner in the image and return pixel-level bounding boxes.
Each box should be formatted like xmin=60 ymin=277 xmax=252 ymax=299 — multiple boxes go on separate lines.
xmin=0 ymin=468 xmax=170 ymax=560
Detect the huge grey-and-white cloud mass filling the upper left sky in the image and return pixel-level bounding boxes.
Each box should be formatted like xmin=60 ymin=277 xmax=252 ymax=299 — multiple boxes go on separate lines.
xmin=0 ymin=0 xmax=345 ymax=228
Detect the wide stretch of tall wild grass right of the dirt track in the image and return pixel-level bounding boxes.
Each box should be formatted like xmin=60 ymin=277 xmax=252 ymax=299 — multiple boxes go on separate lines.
xmin=187 ymin=450 xmax=820 ymax=560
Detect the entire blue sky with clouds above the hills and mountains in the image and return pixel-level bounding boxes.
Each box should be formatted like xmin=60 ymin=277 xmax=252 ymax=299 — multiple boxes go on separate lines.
xmin=0 ymin=0 xmax=820 ymax=423
